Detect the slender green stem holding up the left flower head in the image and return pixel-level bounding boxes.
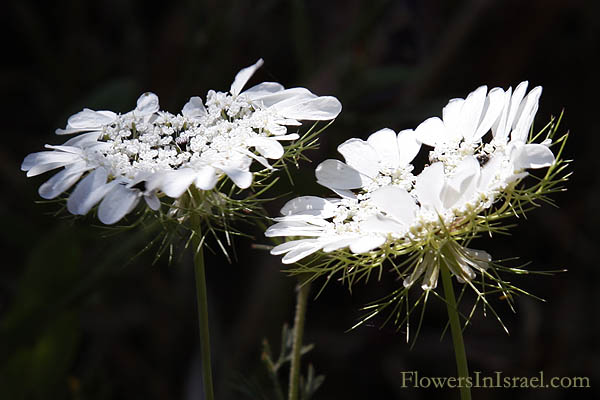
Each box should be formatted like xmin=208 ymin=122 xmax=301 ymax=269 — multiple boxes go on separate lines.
xmin=193 ymin=231 xmax=214 ymax=400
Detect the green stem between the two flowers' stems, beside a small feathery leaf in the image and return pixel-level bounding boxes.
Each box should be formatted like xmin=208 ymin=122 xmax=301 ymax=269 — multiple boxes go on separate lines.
xmin=288 ymin=281 xmax=310 ymax=400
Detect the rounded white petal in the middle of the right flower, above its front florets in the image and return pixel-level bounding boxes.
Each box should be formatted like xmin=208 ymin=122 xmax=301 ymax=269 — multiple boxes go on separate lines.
xmin=371 ymin=186 xmax=419 ymax=226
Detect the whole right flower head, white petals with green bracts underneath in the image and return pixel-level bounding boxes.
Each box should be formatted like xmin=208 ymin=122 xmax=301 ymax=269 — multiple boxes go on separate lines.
xmin=266 ymin=82 xmax=567 ymax=332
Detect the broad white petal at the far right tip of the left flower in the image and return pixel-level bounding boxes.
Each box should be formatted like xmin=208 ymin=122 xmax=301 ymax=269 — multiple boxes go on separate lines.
xmin=274 ymin=96 xmax=342 ymax=121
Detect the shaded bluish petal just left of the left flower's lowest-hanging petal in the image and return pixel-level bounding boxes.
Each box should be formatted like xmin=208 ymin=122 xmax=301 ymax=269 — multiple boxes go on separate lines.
xmin=67 ymin=168 xmax=113 ymax=215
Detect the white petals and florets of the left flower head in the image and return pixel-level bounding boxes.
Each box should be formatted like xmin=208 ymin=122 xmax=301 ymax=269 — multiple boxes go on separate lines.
xmin=21 ymin=60 xmax=341 ymax=224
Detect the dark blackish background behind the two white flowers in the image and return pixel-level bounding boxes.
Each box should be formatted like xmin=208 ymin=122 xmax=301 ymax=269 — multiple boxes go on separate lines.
xmin=0 ymin=0 xmax=600 ymax=399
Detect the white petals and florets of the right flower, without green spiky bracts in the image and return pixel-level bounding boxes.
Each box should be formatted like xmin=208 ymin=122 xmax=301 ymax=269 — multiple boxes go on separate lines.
xmin=266 ymin=82 xmax=555 ymax=290
